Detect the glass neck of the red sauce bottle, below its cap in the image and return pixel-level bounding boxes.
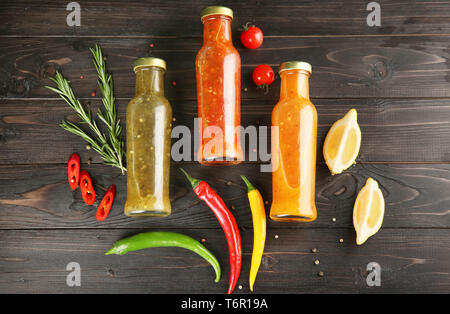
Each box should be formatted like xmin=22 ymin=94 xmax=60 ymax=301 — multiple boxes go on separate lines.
xmin=203 ymin=15 xmax=231 ymax=44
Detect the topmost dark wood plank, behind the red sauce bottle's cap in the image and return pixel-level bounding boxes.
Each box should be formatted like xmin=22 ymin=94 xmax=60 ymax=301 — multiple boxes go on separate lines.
xmin=0 ymin=0 xmax=450 ymax=37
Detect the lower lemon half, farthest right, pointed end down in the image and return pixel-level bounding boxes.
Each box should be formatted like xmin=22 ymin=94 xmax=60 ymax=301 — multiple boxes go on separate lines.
xmin=353 ymin=178 xmax=384 ymax=245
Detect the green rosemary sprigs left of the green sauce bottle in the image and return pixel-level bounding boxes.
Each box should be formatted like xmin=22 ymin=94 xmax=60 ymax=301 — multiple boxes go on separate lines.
xmin=46 ymin=46 xmax=126 ymax=174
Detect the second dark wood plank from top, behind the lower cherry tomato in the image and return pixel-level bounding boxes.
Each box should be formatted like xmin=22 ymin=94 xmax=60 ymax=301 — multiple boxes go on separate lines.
xmin=0 ymin=36 xmax=450 ymax=100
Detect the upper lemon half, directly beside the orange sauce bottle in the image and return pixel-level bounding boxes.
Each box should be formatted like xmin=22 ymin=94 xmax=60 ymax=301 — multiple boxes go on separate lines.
xmin=323 ymin=109 xmax=361 ymax=175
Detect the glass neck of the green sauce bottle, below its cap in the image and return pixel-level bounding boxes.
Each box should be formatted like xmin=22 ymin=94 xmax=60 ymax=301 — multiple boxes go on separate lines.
xmin=136 ymin=66 xmax=165 ymax=94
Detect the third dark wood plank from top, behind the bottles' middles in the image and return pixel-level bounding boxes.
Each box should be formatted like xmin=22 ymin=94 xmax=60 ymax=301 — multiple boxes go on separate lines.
xmin=0 ymin=98 xmax=450 ymax=164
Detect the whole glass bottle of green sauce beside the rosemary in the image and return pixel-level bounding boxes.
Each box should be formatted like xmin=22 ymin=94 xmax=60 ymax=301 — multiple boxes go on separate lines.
xmin=124 ymin=57 xmax=172 ymax=217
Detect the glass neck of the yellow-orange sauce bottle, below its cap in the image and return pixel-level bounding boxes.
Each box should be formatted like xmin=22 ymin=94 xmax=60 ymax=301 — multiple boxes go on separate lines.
xmin=280 ymin=70 xmax=310 ymax=99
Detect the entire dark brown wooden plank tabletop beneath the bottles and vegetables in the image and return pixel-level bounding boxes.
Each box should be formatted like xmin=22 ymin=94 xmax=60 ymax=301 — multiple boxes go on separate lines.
xmin=0 ymin=0 xmax=450 ymax=294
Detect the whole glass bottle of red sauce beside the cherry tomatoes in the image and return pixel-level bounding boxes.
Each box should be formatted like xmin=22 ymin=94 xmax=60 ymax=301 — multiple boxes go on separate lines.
xmin=195 ymin=6 xmax=242 ymax=165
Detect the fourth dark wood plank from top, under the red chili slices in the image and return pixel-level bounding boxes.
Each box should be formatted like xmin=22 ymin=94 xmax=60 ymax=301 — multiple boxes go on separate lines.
xmin=0 ymin=164 xmax=450 ymax=230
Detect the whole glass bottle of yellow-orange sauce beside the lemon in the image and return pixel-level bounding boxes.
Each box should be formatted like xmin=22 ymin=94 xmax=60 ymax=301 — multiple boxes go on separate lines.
xmin=270 ymin=61 xmax=317 ymax=221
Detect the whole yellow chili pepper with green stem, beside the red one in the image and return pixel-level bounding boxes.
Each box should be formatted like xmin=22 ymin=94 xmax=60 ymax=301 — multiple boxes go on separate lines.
xmin=241 ymin=176 xmax=266 ymax=291
